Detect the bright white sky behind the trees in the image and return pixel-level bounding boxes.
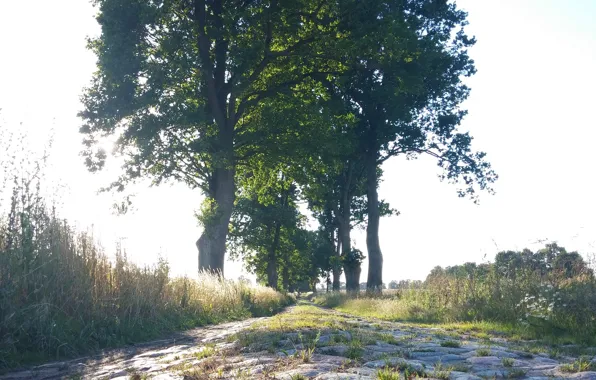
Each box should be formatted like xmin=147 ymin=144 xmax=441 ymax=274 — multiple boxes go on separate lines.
xmin=0 ymin=0 xmax=596 ymax=282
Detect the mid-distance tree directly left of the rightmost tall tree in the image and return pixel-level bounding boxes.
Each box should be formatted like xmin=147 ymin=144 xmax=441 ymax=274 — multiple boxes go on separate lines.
xmin=298 ymin=121 xmax=394 ymax=291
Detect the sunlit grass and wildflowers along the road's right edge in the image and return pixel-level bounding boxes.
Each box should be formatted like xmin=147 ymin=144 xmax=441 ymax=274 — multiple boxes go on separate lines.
xmin=315 ymin=243 xmax=596 ymax=345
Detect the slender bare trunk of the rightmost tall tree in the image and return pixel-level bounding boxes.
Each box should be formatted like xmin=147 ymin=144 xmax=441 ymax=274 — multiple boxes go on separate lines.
xmin=366 ymin=149 xmax=383 ymax=292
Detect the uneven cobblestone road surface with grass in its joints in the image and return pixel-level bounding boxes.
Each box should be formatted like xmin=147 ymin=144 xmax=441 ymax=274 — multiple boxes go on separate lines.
xmin=0 ymin=308 xmax=596 ymax=380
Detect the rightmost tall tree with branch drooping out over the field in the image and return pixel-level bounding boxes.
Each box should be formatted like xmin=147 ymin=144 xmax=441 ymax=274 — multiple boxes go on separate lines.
xmin=334 ymin=0 xmax=497 ymax=290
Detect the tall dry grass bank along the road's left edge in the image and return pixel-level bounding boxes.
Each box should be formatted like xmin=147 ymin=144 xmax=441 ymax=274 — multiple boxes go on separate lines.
xmin=0 ymin=128 xmax=291 ymax=369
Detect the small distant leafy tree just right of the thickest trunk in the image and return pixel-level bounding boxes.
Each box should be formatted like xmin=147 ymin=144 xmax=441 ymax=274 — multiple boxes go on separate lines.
xmin=229 ymin=162 xmax=333 ymax=291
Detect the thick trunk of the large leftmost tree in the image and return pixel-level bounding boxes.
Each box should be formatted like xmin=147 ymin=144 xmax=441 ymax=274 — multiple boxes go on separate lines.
xmin=196 ymin=168 xmax=235 ymax=277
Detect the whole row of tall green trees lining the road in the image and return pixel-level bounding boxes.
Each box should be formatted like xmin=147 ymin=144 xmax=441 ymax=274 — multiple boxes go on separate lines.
xmin=80 ymin=0 xmax=497 ymax=290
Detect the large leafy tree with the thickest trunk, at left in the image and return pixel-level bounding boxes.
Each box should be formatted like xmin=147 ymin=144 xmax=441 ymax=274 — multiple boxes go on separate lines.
xmin=80 ymin=0 xmax=350 ymax=274
